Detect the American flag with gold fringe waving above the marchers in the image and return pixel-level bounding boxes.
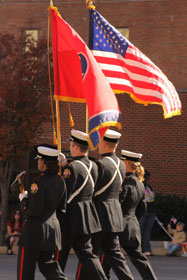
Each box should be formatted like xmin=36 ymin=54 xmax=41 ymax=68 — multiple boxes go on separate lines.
xmin=89 ymin=9 xmax=181 ymax=118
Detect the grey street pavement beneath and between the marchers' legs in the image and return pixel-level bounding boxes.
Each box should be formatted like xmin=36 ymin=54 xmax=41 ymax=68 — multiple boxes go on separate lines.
xmin=0 ymin=255 xmax=187 ymax=280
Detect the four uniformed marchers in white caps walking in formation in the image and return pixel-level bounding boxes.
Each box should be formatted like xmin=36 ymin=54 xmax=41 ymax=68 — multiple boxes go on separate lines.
xmin=11 ymin=129 xmax=157 ymax=280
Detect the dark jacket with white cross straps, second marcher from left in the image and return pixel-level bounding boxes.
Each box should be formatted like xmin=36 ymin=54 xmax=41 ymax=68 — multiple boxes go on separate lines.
xmin=63 ymin=156 xmax=101 ymax=236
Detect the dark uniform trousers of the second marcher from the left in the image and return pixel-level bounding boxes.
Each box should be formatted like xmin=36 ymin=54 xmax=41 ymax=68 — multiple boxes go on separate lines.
xmin=59 ymin=232 xmax=107 ymax=280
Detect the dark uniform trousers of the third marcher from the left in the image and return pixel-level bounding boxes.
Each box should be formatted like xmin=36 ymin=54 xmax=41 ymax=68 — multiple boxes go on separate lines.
xmin=77 ymin=232 xmax=134 ymax=280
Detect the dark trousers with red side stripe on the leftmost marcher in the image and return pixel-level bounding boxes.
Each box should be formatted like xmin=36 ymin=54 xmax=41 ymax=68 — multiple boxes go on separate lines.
xmin=17 ymin=247 xmax=68 ymax=280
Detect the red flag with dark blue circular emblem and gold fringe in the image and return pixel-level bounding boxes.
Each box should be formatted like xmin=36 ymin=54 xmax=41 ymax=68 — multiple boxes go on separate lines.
xmin=50 ymin=7 xmax=121 ymax=149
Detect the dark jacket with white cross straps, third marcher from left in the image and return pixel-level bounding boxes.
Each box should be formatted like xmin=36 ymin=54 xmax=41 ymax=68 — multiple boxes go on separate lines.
xmin=94 ymin=153 xmax=125 ymax=232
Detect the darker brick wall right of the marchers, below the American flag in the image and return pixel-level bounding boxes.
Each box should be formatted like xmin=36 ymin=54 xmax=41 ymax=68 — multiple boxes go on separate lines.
xmin=118 ymin=94 xmax=187 ymax=196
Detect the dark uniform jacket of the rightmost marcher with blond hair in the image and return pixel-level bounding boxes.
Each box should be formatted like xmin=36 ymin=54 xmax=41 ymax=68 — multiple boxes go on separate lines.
xmin=120 ymin=173 xmax=146 ymax=247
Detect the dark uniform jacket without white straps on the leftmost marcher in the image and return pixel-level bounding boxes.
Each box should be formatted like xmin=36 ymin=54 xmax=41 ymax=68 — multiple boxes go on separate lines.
xmin=16 ymin=171 xmax=66 ymax=251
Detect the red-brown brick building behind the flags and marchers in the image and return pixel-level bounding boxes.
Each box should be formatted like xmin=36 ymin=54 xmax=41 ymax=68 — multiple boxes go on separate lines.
xmin=0 ymin=0 xmax=187 ymax=196
